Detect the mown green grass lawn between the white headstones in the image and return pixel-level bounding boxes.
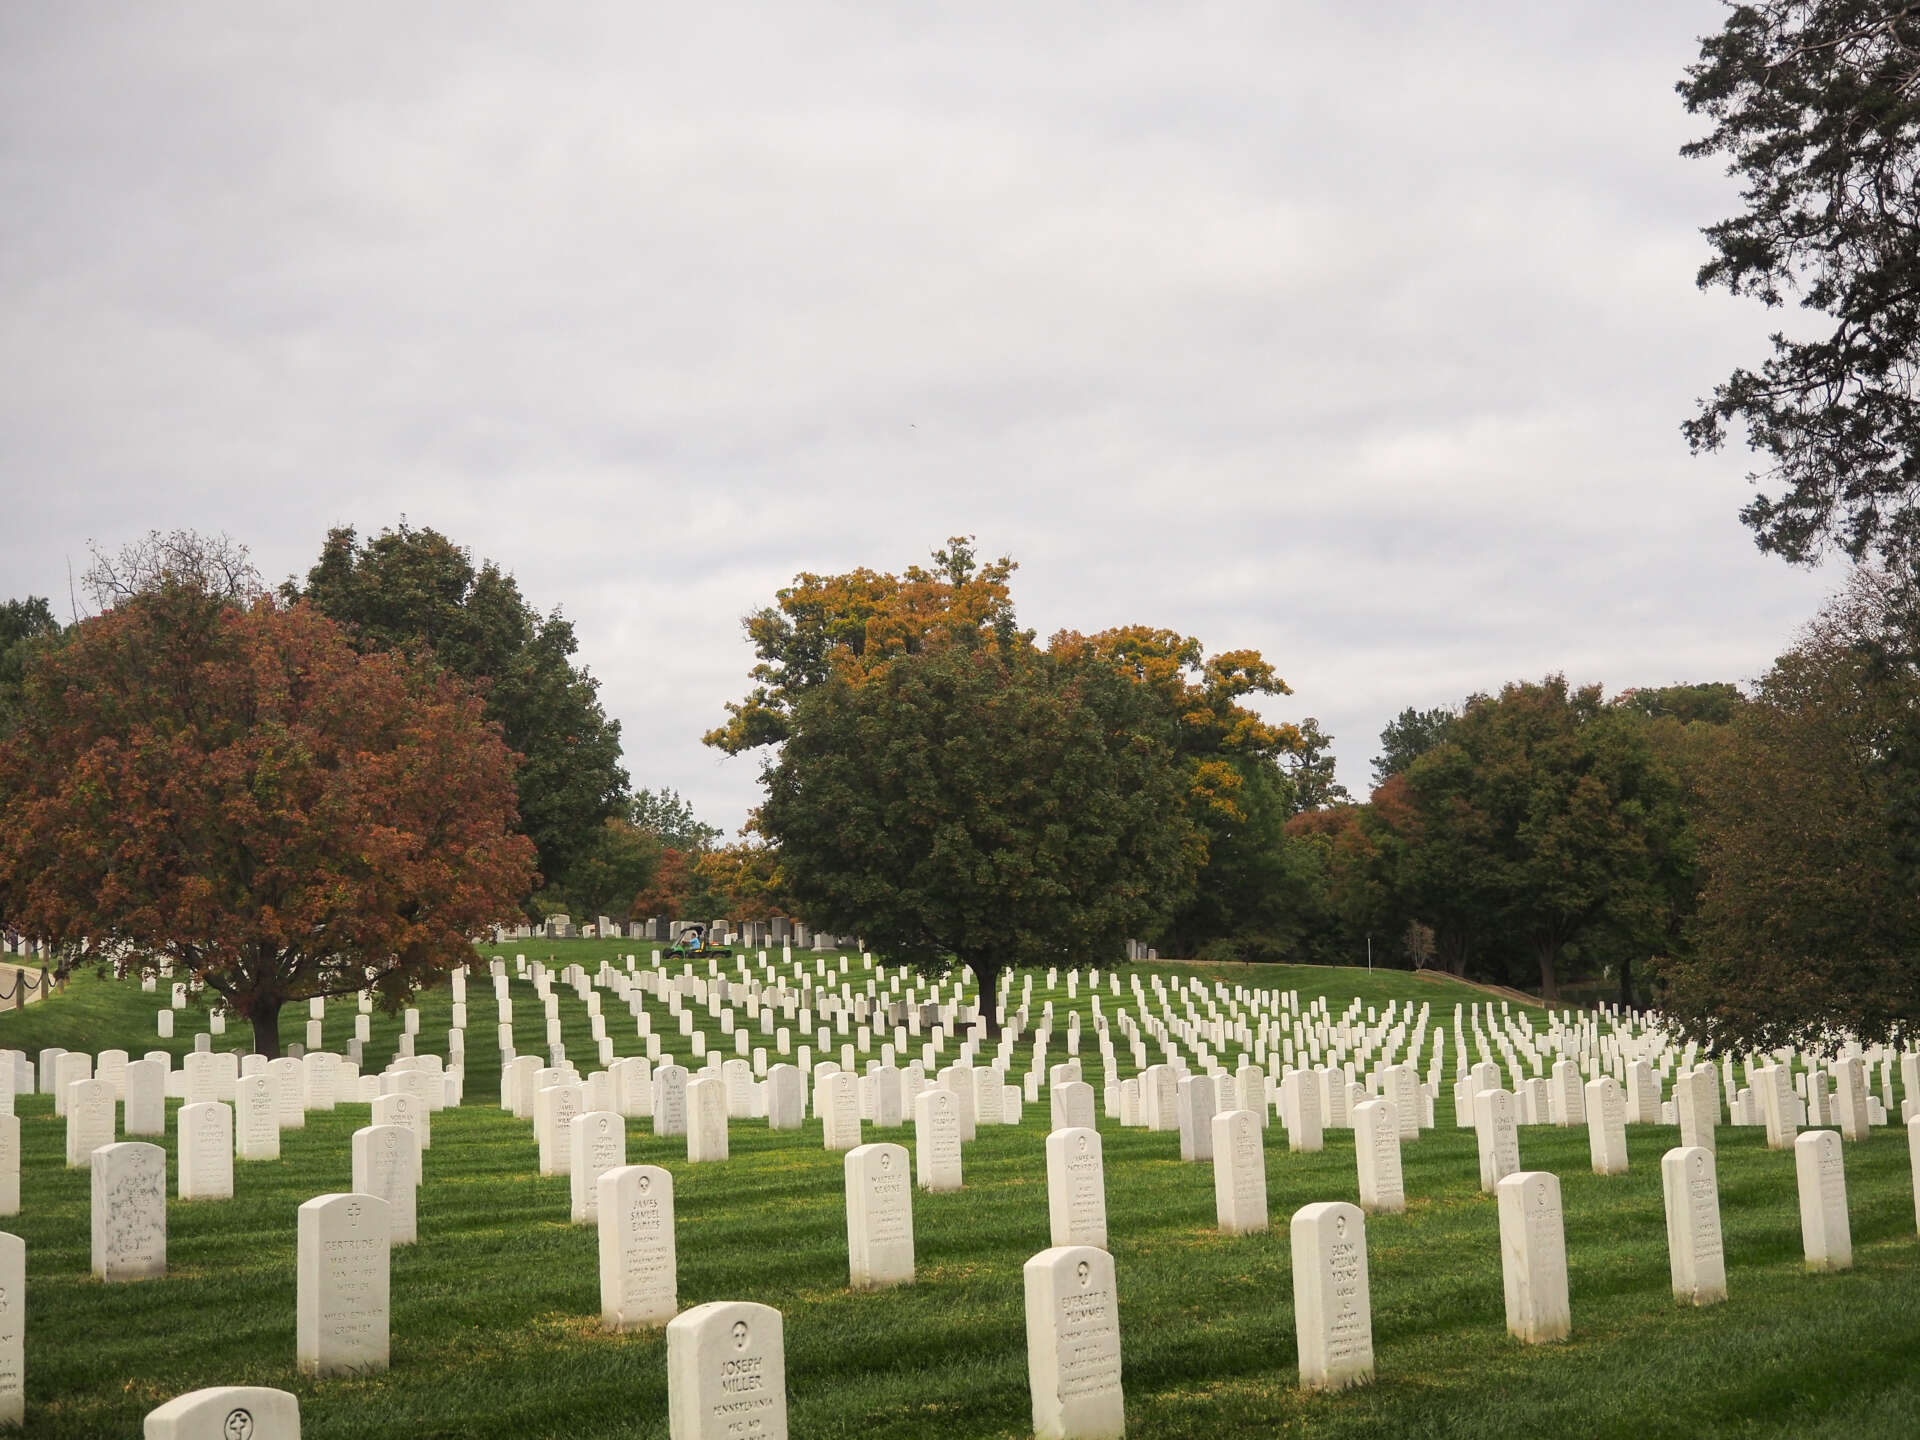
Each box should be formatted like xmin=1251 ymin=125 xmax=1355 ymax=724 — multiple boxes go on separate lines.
xmin=0 ymin=941 xmax=1920 ymax=1440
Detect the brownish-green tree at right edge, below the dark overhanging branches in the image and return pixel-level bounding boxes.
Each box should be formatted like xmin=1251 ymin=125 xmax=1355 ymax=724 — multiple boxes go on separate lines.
xmin=1659 ymin=572 xmax=1920 ymax=1048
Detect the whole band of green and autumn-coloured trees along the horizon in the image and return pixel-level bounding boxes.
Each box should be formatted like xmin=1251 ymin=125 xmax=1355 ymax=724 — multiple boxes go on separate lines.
xmin=0 ymin=526 xmax=1920 ymax=1043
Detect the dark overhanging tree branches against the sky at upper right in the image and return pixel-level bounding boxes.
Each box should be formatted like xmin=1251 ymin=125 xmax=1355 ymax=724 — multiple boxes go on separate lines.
xmin=1678 ymin=0 xmax=1920 ymax=561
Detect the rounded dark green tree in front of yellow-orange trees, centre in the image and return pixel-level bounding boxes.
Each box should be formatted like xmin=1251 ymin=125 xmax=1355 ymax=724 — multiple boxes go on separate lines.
xmin=758 ymin=643 xmax=1196 ymax=1031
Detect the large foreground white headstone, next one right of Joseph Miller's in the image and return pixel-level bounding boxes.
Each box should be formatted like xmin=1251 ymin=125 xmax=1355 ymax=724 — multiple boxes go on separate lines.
xmin=1023 ymin=1244 xmax=1127 ymax=1440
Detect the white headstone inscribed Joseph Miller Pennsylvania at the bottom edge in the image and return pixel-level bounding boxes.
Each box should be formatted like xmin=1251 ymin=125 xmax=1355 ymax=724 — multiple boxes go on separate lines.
xmin=666 ymin=1300 xmax=787 ymax=1440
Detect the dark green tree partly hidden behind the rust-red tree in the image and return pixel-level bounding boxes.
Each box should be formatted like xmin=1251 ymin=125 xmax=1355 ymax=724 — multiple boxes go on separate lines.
xmin=284 ymin=522 xmax=628 ymax=895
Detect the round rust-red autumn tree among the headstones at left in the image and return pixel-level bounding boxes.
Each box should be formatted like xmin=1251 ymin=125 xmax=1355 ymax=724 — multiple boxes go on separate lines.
xmin=0 ymin=582 xmax=534 ymax=1056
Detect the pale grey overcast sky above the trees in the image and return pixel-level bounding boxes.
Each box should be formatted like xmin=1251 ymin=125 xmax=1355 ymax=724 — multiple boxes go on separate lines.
xmin=0 ymin=0 xmax=1834 ymax=828
